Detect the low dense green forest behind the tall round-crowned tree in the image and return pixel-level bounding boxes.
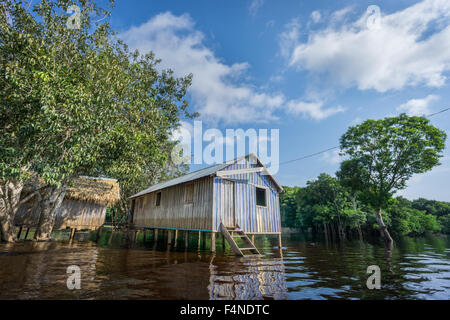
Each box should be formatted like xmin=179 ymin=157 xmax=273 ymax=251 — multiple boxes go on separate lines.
xmin=280 ymin=174 xmax=450 ymax=240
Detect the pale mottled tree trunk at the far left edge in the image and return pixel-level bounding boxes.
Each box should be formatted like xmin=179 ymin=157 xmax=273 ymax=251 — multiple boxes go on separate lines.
xmin=0 ymin=181 xmax=24 ymax=242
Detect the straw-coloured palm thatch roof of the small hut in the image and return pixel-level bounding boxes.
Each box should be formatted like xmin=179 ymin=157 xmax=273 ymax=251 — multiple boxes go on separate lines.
xmin=65 ymin=177 xmax=120 ymax=206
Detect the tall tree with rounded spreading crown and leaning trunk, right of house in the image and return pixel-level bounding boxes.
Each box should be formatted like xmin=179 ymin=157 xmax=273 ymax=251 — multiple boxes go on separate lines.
xmin=337 ymin=114 xmax=446 ymax=244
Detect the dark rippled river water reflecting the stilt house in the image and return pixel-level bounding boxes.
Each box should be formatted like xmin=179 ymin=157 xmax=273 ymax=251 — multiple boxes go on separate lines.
xmin=0 ymin=231 xmax=450 ymax=299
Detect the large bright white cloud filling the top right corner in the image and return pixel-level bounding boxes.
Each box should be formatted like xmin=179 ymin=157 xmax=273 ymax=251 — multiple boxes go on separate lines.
xmin=280 ymin=0 xmax=450 ymax=92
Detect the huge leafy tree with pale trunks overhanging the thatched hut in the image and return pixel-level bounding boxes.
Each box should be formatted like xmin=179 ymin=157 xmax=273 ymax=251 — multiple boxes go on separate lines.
xmin=0 ymin=0 xmax=191 ymax=241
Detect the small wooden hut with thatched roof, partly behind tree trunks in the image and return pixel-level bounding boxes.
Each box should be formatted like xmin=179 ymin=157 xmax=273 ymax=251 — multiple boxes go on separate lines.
xmin=14 ymin=177 xmax=120 ymax=230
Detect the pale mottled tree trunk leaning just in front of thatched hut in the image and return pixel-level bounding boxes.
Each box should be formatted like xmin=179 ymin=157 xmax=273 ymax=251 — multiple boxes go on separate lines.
xmin=34 ymin=185 xmax=67 ymax=241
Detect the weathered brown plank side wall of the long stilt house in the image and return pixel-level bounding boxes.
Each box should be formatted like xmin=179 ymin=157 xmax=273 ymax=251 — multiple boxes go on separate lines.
xmin=133 ymin=177 xmax=213 ymax=230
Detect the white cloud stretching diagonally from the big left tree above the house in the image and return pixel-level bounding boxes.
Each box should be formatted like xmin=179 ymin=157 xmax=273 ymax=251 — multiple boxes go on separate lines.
xmin=119 ymin=12 xmax=285 ymax=123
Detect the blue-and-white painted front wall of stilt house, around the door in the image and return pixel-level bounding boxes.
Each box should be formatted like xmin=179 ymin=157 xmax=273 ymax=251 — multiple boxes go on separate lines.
xmin=213 ymin=159 xmax=281 ymax=233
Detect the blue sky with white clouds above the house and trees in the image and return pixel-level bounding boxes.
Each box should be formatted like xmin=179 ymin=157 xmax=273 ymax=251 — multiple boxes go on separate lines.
xmin=107 ymin=0 xmax=450 ymax=201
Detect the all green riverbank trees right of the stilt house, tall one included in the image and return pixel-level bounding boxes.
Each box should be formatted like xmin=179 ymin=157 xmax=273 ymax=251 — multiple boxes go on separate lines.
xmin=280 ymin=114 xmax=450 ymax=241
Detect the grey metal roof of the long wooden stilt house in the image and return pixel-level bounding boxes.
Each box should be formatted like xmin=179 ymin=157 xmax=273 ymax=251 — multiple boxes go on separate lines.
xmin=130 ymin=154 xmax=283 ymax=198
